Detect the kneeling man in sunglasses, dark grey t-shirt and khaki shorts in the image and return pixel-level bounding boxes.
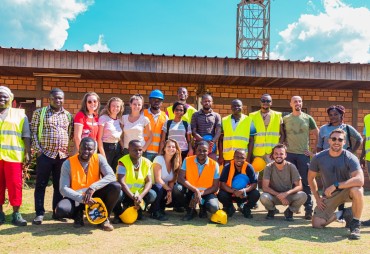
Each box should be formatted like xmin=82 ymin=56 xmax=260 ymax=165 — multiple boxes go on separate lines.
xmin=308 ymin=129 xmax=364 ymax=240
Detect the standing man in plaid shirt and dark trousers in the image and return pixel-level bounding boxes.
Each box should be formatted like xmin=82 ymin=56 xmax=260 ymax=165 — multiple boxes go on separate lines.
xmin=31 ymin=88 xmax=73 ymax=225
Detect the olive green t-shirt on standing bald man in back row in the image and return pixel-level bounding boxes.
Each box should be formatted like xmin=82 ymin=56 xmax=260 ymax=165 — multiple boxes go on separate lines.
xmin=283 ymin=112 xmax=317 ymax=154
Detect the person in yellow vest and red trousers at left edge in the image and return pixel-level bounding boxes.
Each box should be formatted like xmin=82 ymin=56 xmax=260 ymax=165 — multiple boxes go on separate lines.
xmin=0 ymin=86 xmax=31 ymax=226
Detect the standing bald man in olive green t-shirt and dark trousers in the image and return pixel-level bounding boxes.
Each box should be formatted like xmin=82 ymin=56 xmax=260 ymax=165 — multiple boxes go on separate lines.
xmin=283 ymin=96 xmax=319 ymax=220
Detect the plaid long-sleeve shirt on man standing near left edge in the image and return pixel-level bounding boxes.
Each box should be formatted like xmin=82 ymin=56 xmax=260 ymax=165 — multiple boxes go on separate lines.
xmin=31 ymin=105 xmax=73 ymax=159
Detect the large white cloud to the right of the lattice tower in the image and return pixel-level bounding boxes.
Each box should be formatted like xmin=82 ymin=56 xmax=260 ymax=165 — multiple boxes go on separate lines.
xmin=270 ymin=0 xmax=370 ymax=63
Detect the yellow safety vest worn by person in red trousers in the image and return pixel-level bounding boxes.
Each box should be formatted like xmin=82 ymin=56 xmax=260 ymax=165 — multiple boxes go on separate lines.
xmin=0 ymin=108 xmax=26 ymax=162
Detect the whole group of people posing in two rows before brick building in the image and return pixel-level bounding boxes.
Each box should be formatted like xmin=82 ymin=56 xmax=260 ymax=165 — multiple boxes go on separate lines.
xmin=0 ymin=86 xmax=370 ymax=239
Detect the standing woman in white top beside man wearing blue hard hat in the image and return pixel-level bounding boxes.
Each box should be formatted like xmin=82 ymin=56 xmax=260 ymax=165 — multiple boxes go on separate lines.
xmin=121 ymin=94 xmax=152 ymax=155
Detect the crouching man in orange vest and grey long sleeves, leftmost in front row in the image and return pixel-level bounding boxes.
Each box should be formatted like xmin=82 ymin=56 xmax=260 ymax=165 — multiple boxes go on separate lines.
xmin=55 ymin=137 xmax=121 ymax=231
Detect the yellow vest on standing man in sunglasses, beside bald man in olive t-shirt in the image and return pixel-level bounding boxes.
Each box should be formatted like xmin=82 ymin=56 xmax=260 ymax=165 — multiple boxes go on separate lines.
xmin=249 ymin=110 xmax=281 ymax=156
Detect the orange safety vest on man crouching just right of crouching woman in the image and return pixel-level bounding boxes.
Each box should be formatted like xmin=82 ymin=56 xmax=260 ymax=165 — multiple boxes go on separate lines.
xmin=185 ymin=155 xmax=217 ymax=190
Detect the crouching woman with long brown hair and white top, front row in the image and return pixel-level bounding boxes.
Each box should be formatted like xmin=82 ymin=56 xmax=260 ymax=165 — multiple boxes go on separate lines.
xmin=150 ymin=139 xmax=181 ymax=221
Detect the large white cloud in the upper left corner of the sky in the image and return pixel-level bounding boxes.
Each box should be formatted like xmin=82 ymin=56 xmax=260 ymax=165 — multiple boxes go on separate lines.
xmin=0 ymin=0 xmax=93 ymax=49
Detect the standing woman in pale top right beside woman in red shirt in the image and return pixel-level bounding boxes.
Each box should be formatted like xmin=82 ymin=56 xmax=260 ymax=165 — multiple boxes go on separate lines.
xmin=98 ymin=97 xmax=124 ymax=172
